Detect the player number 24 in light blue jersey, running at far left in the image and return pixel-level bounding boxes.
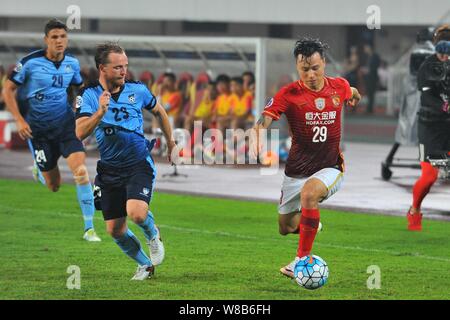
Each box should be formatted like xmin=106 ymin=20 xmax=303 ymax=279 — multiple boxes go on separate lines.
xmin=3 ymin=19 xmax=100 ymax=241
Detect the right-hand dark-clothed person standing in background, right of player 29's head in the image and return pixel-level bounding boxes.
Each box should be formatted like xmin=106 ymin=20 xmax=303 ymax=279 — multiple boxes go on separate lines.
xmin=364 ymin=44 xmax=380 ymax=114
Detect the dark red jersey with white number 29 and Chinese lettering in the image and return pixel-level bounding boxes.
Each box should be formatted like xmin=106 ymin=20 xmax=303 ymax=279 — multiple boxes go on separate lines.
xmin=263 ymin=77 xmax=352 ymax=177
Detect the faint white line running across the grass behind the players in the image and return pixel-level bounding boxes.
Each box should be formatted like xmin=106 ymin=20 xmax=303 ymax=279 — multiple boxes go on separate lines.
xmin=0 ymin=204 xmax=450 ymax=263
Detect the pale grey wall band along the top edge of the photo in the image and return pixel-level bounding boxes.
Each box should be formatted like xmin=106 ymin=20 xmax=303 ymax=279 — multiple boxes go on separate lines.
xmin=0 ymin=0 xmax=449 ymax=26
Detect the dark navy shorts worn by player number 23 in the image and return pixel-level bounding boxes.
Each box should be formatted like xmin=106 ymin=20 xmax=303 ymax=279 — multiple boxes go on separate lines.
xmin=94 ymin=157 xmax=156 ymax=220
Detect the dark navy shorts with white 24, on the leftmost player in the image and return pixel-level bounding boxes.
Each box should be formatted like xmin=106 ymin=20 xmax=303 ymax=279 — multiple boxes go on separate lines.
xmin=31 ymin=118 xmax=84 ymax=172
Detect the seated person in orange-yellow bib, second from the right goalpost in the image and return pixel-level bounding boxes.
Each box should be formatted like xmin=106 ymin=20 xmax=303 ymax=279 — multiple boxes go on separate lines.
xmin=229 ymin=77 xmax=253 ymax=129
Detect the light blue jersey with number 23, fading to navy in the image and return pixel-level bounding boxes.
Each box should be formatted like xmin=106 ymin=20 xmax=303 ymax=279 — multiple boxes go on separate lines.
xmin=76 ymin=81 xmax=156 ymax=167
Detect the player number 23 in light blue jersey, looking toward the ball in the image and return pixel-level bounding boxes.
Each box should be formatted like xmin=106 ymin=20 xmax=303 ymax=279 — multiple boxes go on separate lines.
xmin=76 ymin=43 xmax=175 ymax=280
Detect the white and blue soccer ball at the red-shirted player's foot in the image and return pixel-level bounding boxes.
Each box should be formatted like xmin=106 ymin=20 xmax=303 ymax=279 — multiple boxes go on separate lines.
xmin=294 ymin=255 xmax=328 ymax=290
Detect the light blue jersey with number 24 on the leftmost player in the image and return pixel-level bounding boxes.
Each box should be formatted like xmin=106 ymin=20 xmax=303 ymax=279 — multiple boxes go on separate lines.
xmin=10 ymin=50 xmax=83 ymax=131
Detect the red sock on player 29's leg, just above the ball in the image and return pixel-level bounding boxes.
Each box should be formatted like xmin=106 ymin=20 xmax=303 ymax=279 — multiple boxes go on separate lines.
xmin=297 ymin=208 xmax=320 ymax=258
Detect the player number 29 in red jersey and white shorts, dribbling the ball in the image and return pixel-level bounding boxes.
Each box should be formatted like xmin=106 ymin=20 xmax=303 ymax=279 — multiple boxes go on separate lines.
xmin=254 ymin=38 xmax=361 ymax=278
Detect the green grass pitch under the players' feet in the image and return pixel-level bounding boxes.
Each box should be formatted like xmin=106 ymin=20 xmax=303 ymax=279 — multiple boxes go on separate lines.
xmin=0 ymin=180 xmax=450 ymax=300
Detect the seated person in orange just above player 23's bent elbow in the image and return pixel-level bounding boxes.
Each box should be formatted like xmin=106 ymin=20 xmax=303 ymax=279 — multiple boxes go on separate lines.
xmin=161 ymin=72 xmax=182 ymax=128
